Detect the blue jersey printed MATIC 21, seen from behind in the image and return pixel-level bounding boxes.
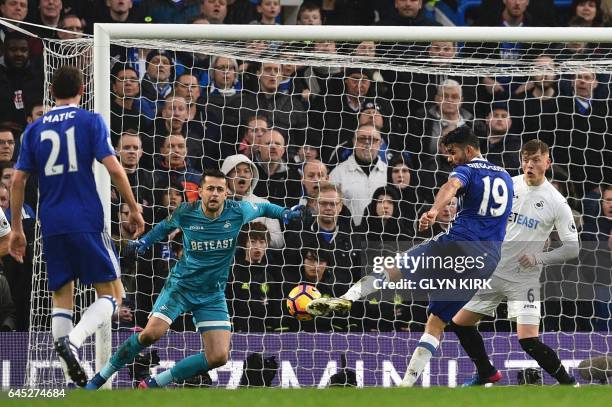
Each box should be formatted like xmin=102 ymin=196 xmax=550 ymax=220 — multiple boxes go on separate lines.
xmin=15 ymin=106 xmax=115 ymax=236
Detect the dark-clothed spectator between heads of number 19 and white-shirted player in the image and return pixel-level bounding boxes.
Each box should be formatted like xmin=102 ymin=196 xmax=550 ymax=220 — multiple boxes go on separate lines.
xmin=480 ymin=107 xmax=522 ymax=176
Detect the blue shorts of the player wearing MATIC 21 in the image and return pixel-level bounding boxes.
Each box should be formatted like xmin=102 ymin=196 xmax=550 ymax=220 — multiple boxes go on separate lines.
xmin=43 ymin=232 xmax=121 ymax=291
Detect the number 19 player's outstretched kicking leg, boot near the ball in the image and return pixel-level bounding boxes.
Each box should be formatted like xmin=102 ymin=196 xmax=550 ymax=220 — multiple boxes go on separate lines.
xmin=306 ymin=267 xmax=402 ymax=317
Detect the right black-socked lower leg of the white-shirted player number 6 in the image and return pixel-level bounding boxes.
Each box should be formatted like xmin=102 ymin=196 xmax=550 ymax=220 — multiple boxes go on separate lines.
xmin=516 ymin=321 xmax=577 ymax=385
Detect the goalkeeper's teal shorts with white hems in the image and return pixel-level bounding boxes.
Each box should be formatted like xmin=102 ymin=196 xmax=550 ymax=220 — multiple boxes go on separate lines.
xmin=150 ymin=280 xmax=232 ymax=333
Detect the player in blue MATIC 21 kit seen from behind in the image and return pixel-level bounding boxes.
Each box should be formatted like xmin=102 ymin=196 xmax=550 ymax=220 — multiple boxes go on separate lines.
xmin=9 ymin=66 xmax=144 ymax=386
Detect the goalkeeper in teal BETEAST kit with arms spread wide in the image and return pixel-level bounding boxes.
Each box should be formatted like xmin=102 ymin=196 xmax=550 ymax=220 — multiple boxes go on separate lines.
xmin=86 ymin=170 xmax=302 ymax=390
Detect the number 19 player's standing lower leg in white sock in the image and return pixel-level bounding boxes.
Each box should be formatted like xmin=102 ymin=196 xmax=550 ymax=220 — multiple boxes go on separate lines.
xmin=400 ymin=314 xmax=447 ymax=387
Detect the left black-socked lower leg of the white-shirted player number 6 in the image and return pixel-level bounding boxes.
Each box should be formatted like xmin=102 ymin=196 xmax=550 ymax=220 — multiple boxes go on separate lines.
xmin=452 ymin=308 xmax=502 ymax=386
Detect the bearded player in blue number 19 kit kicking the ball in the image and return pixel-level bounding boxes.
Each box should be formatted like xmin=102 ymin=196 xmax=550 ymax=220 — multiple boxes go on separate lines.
xmin=308 ymin=126 xmax=513 ymax=387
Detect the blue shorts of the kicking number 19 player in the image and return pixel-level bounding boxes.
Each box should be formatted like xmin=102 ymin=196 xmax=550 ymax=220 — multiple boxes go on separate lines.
xmin=400 ymin=235 xmax=500 ymax=323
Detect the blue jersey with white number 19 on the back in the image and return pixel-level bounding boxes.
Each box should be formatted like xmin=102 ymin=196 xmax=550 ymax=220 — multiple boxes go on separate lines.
xmin=449 ymin=159 xmax=514 ymax=245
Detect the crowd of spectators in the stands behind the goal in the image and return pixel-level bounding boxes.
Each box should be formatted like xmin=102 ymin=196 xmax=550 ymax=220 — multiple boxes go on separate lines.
xmin=0 ymin=0 xmax=612 ymax=332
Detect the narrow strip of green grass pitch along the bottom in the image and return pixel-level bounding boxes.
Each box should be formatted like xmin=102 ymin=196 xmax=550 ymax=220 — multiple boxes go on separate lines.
xmin=0 ymin=386 xmax=612 ymax=407
